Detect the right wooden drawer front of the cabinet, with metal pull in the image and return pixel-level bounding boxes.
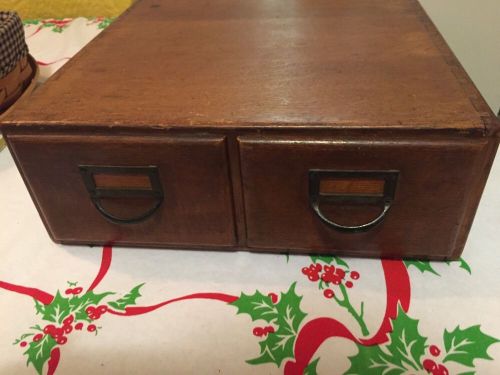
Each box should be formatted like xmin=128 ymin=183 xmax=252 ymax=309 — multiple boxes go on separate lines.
xmin=239 ymin=137 xmax=486 ymax=257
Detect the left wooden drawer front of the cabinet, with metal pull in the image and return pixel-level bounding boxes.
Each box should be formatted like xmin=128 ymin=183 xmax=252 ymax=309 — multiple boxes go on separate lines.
xmin=9 ymin=135 xmax=235 ymax=246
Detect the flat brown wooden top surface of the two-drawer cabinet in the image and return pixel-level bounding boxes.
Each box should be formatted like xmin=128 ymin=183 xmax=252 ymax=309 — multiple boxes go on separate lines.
xmin=5 ymin=0 xmax=493 ymax=133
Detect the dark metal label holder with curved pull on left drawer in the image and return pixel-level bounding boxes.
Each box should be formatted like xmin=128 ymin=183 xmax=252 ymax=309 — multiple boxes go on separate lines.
xmin=78 ymin=165 xmax=164 ymax=224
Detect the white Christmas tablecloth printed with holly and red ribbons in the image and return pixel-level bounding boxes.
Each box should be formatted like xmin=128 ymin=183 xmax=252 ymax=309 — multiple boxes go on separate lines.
xmin=0 ymin=18 xmax=500 ymax=375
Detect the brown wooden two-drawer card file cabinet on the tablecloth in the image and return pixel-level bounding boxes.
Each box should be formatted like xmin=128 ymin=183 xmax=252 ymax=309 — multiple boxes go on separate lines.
xmin=2 ymin=0 xmax=498 ymax=259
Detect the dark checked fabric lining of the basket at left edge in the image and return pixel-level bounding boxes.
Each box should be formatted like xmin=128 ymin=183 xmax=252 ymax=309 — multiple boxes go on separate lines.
xmin=0 ymin=11 xmax=28 ymax=78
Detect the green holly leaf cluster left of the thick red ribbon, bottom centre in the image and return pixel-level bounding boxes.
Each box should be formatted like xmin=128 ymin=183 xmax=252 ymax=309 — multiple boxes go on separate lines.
xmin=232 ymin=283 xmax=306 ymax=367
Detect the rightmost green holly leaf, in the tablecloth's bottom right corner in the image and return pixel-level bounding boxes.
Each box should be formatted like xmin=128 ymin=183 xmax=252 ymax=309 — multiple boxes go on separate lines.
xmin=443 ymin=325 xmax=500 ymax=367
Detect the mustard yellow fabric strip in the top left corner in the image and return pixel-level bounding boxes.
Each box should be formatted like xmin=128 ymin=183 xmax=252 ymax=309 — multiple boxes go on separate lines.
xmin=0 ymin=0 xmax=132 ymax=19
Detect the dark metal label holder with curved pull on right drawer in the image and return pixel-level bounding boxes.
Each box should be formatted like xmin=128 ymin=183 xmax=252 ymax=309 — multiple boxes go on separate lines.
xmin=309 ymin=169 xmax=399 ymax=233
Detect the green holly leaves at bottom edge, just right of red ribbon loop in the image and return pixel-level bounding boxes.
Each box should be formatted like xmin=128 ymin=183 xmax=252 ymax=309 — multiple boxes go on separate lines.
xmin=347 ymin=306 xmax=427 ymax=375
